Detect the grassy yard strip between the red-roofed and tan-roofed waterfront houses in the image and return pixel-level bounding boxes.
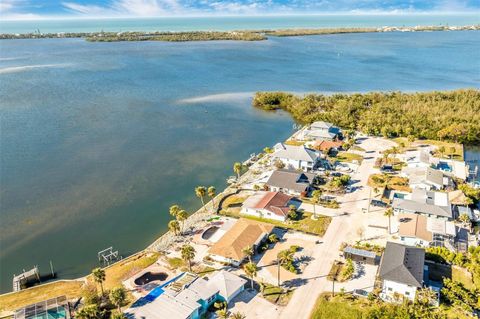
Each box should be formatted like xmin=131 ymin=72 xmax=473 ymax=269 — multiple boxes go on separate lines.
xmin=220 ymin=210 xmax=332 ymax=236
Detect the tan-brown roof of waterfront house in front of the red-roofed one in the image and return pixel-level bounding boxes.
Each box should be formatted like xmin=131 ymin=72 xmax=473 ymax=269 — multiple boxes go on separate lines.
xmin=208 ymin=218 xmax=274 ymax=261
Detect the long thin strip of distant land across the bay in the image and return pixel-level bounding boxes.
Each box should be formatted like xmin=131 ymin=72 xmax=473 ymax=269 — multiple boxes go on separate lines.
xmin=0 ymin=24 xmax=480 ymax=42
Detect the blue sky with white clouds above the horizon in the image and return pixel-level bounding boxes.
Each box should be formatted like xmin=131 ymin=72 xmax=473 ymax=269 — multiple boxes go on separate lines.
xmin=0 ymin=0 xmax=480 ymax=19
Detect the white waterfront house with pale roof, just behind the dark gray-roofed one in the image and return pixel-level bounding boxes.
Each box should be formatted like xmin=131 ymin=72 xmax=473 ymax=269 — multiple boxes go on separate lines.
xmin=271 ymin=143 xmax=320 ymax=171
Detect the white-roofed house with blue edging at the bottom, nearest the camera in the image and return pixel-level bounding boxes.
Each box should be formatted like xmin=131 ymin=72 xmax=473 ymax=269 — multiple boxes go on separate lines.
xmin=125 ymin=270 xmax=247 ymax=319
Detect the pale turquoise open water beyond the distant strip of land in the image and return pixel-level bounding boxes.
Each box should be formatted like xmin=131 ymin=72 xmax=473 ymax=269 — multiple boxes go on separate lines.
xmin=0 ymin=13 xmax=480 ymax=33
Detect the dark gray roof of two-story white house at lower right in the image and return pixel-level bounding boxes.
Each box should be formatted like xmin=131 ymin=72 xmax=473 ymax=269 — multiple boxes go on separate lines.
xmin=379 ymin=242 xmax=425 ymax=288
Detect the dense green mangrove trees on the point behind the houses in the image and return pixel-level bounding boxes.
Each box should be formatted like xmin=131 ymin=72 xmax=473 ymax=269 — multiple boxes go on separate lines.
xmin=252 ymin=89 xmax=480 ymax=145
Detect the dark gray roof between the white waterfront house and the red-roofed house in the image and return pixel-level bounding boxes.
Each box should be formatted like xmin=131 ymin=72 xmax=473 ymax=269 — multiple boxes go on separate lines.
xmin=266 ymin=169 xmax=315 ymax=193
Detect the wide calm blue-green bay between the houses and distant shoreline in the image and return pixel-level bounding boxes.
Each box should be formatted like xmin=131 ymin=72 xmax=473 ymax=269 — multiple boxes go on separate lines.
xmin=0 ymin=31 xmax=480 ymax=291
